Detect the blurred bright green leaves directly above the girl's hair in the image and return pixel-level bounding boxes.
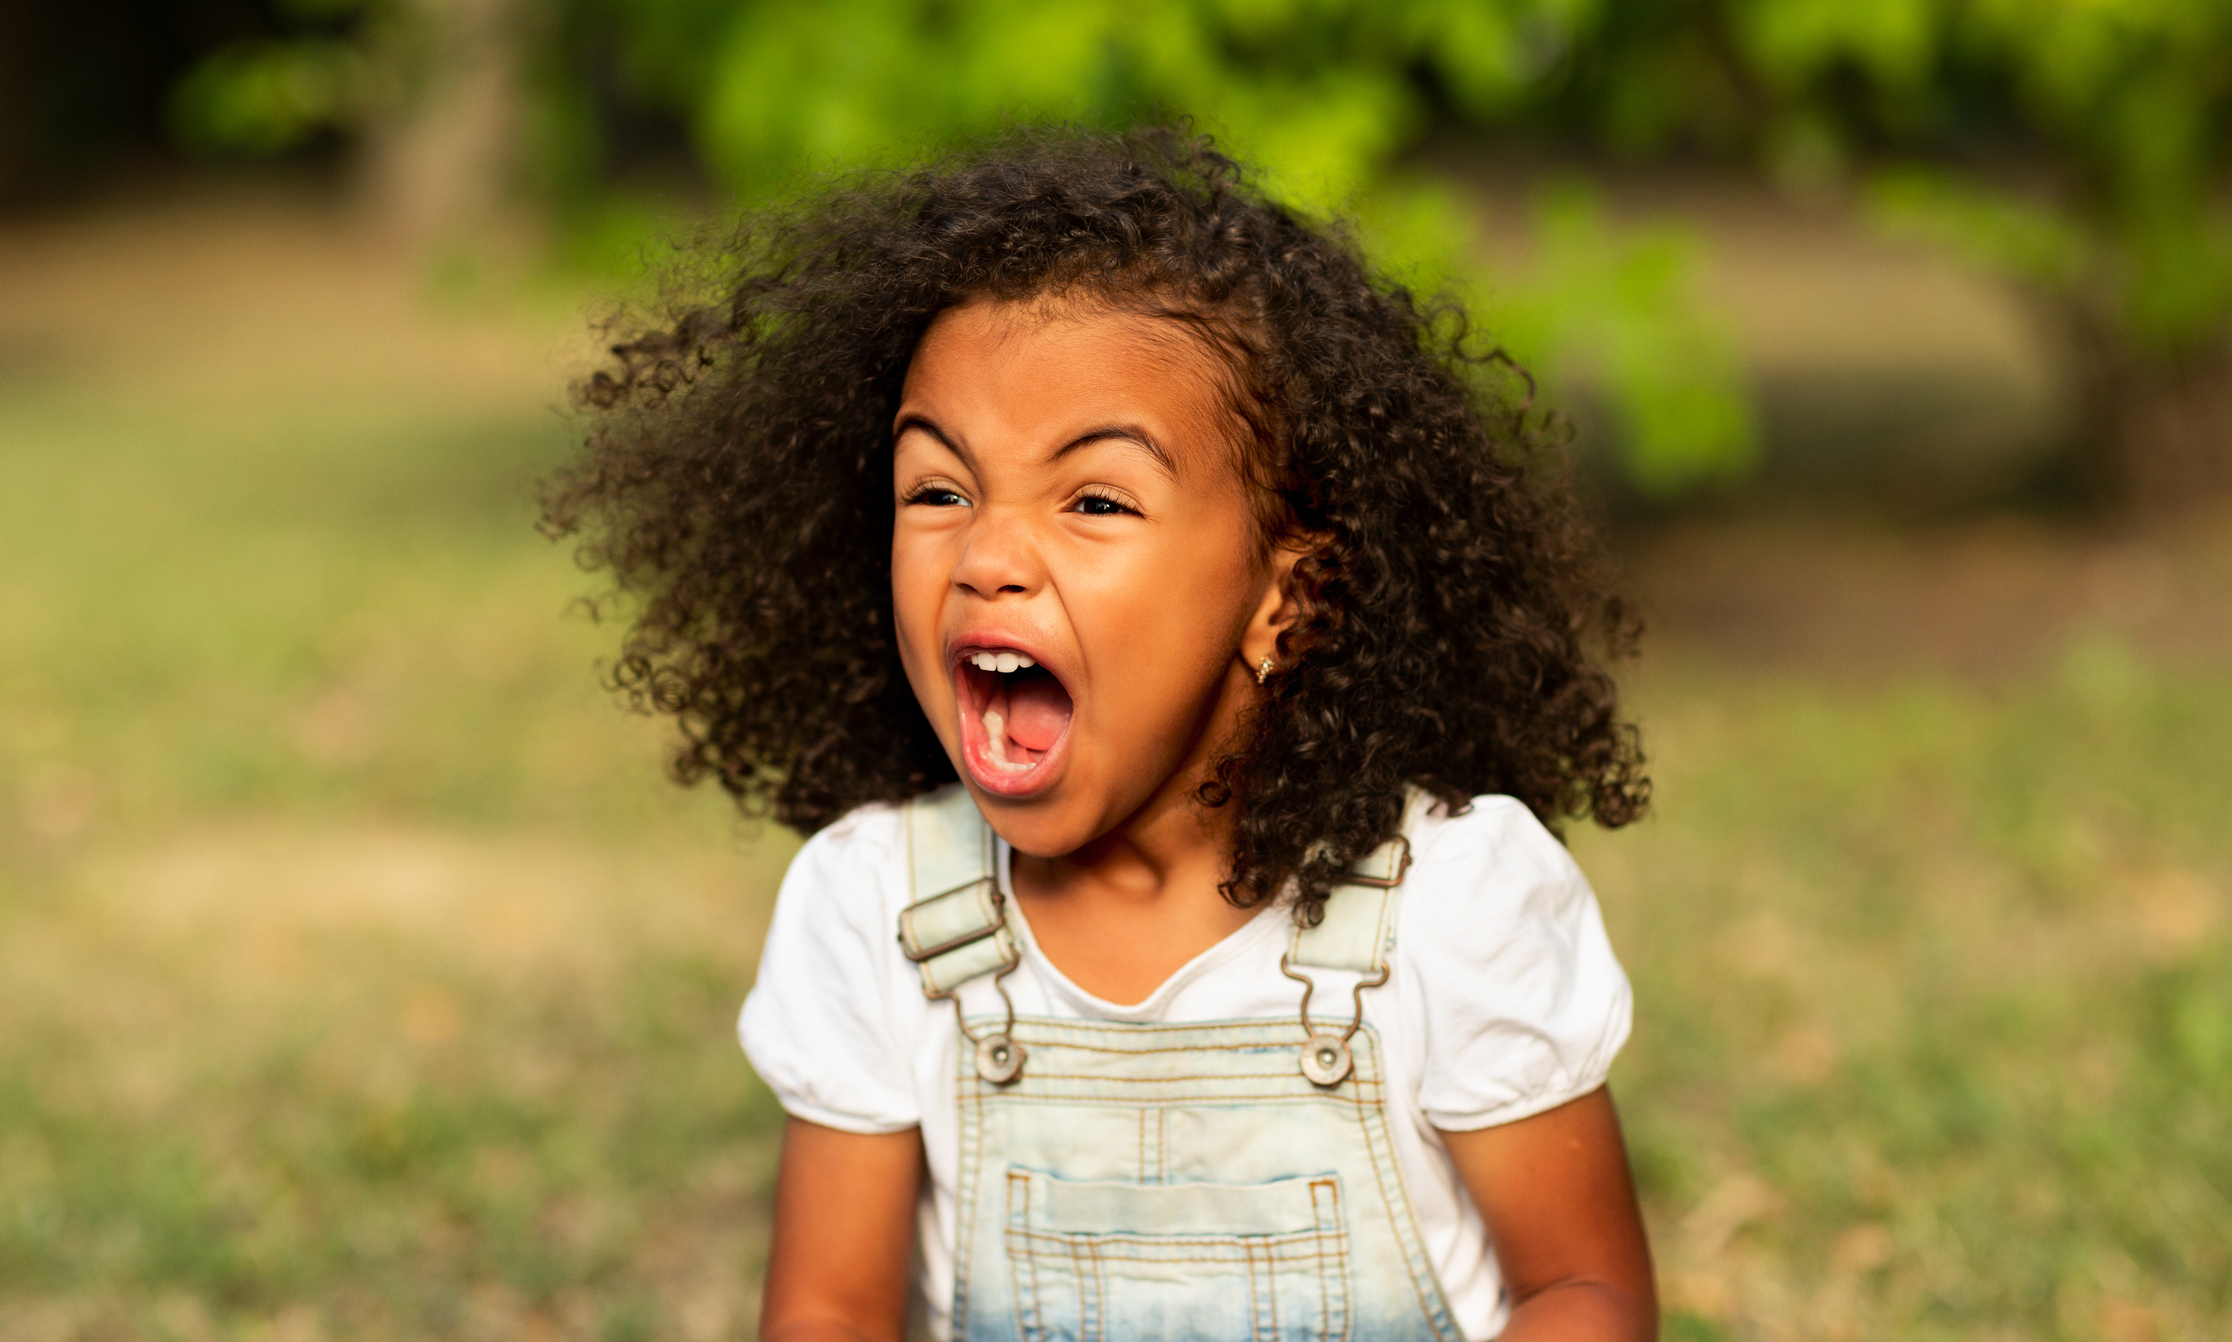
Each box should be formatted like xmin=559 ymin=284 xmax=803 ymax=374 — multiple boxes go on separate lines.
xmin=674 ymin=0 xmax=1587 ymax=208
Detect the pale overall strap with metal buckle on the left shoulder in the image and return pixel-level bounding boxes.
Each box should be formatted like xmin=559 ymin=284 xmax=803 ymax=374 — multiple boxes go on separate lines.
xmin=899 ymin=784 xmax=1022 ymax=998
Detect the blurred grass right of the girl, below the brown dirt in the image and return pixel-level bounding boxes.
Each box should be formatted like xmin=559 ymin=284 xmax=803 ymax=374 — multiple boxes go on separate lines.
xmin=1580 ymin=652 xmax=2232 ymax=1338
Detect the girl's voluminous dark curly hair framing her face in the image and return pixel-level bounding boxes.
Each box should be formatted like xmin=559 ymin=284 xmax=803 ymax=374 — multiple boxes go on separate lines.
xmin=545 ymin=127 xmax=1649 ymax=922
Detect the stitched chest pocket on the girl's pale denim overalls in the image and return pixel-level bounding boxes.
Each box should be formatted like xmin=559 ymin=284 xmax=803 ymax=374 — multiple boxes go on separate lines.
xmin=1007 ymin=1166 xmax=1350 ymax=1342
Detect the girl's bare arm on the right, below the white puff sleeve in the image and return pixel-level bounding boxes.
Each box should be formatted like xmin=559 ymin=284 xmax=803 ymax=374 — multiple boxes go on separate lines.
xmin=1442 ymin=1087 xmax=1658 ymax=1342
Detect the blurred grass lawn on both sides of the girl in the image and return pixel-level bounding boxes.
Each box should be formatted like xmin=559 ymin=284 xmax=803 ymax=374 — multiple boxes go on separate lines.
xmin=0 ymin=201 xmax=2232 ymax=1342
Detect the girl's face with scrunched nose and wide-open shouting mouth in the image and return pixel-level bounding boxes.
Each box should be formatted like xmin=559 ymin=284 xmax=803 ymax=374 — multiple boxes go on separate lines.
xmin=891 ymin=301 xmax=1292 ymax=857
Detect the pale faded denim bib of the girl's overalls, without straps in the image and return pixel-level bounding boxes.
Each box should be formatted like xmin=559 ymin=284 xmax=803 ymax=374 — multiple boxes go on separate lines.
xmin=953 ymin=1018 xmax=1462 ymax=1342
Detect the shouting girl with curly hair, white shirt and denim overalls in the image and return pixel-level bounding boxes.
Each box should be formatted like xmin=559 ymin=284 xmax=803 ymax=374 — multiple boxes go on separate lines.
xmin=549 ymin=132 xmax=1656 ymax=1342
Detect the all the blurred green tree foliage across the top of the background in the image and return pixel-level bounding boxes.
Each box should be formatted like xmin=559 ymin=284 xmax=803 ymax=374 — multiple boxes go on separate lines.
xmin=181 ymin=0 xmax=2232 ymax=500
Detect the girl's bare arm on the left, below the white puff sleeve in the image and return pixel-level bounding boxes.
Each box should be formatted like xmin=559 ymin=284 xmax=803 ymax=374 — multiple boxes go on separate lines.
xmin=759 ymin=1119 xmax=922 ymax=1342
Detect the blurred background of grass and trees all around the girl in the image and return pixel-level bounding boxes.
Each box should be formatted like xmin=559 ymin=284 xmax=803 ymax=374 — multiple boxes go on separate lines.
xmin=0 ymin=0 xmax=2232 ymax=1342
